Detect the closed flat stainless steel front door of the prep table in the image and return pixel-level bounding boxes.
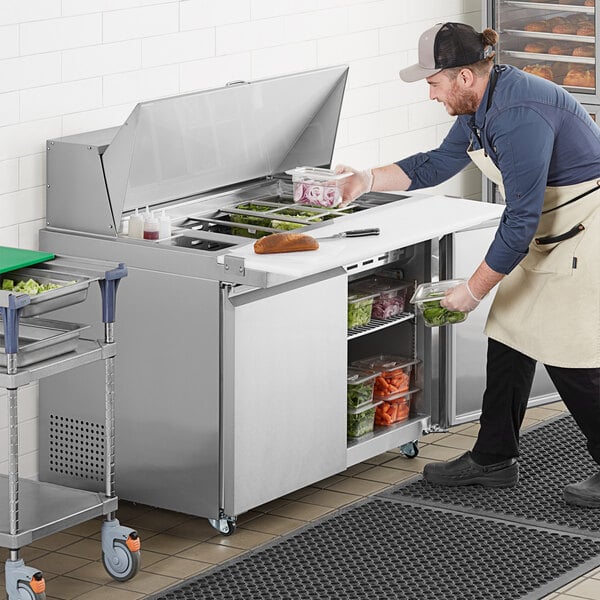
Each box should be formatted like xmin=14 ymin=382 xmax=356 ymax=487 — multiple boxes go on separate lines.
xmin=222 ymin=269 xmax=347 ymax=515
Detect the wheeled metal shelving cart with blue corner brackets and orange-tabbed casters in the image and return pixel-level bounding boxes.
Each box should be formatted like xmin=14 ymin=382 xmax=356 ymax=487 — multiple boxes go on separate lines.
xmin=0 ymin=257 xmax=140 ymax=600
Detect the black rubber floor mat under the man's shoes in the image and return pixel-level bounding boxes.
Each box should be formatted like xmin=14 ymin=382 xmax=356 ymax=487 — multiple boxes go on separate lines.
xmin=380 ymin=415 xmax=600 ymax=537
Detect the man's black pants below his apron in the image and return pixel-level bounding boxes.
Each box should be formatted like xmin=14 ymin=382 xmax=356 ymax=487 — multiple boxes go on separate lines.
xmin=473 ymin=339 xmax=600 ymax=464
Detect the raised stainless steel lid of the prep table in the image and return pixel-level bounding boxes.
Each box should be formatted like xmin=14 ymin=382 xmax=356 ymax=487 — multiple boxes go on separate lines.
xmin=102 ymin=66 xmax=348 ymax=217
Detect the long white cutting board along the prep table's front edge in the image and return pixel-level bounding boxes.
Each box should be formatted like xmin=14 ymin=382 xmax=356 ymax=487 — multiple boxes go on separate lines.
xmin=218 ymin=195 xmax=504 ymax=285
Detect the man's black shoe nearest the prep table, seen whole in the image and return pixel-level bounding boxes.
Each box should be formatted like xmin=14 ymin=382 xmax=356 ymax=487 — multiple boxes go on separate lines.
xmin=423 ymin=452 xmax=519 ymax=487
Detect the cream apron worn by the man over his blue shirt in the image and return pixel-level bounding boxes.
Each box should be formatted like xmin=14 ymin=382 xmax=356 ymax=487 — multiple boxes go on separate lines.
xmin=469 ymin=149 xmax=600 ymax=368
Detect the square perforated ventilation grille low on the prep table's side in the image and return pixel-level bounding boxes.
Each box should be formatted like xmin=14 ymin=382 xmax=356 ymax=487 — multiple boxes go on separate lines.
xmin=48 ymin=414 xmax=105 ymax=482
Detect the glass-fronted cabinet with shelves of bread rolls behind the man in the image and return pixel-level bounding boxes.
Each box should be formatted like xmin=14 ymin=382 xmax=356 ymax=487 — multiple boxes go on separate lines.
xmin=485 ymin=0 xmax=600 ymax=104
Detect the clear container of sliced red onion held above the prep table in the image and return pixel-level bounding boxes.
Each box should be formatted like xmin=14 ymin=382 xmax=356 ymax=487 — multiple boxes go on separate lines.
xmin=286 ymin=167 xmax=352 ymax=208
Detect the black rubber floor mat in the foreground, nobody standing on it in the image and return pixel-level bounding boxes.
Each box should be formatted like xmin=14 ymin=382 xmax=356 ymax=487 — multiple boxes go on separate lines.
xmin=152 ymin=498 xmax=600 ymax=600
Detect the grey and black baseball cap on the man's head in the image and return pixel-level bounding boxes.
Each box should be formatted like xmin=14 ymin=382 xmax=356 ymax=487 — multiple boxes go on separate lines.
xmin=400 ymin=23 xmax=492 ymax=82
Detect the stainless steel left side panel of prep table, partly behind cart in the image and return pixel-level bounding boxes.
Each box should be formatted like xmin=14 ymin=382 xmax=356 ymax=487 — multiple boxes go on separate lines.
xmin=39 ymin=262 xmax=220 ymax=517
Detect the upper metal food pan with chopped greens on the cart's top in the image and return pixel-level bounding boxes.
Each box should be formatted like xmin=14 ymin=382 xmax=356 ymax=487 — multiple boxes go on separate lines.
xmin=0 ymin=268 xmax=92 ymax=317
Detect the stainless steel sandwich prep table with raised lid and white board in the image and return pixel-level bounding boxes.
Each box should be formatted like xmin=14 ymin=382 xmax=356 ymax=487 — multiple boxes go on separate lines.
xmin=39 ymin=66 xmax=502 ymax=534
